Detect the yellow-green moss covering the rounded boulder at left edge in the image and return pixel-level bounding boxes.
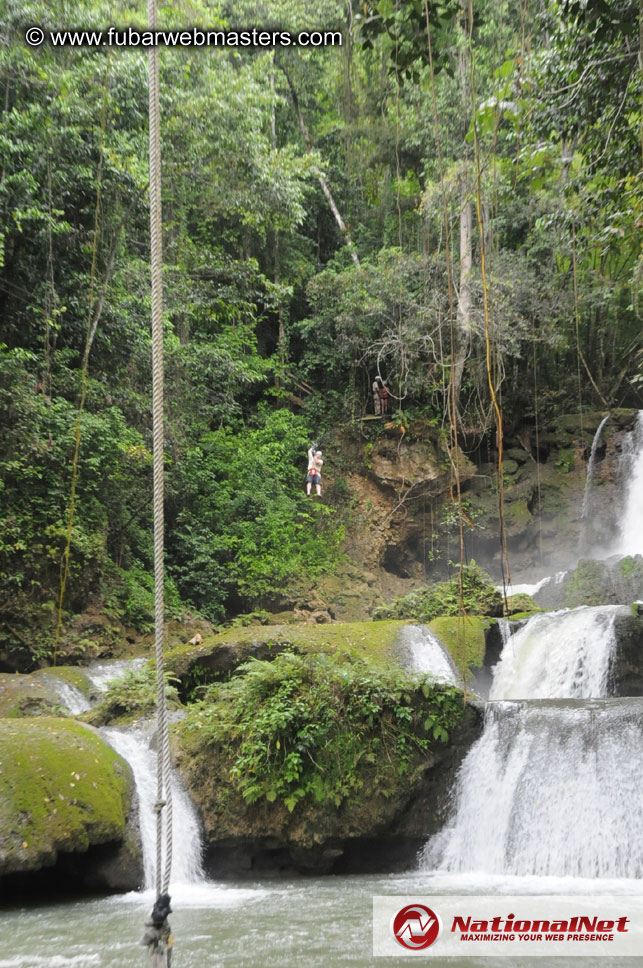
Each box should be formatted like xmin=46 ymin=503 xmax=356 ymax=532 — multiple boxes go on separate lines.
xmin=0 ymin=718 xmax=132 ymax=873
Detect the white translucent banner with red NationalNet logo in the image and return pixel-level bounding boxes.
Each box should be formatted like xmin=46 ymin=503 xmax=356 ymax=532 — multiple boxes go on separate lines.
xmin=373 ymin=894 xmax=643 ymax=958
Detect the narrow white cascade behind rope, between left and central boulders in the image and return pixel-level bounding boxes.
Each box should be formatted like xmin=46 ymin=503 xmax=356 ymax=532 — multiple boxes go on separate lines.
xmin=101 ymin=727 xmax=204 ymax=888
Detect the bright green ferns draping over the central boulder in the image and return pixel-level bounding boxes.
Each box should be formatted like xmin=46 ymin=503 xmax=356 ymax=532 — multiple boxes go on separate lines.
xmin=182 ymin=652 xmax=463 ymax=811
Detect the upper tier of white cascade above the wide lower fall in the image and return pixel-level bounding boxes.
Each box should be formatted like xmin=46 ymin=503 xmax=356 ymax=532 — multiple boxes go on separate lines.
xmin=489 ymin=605 xmax=620 ymax=700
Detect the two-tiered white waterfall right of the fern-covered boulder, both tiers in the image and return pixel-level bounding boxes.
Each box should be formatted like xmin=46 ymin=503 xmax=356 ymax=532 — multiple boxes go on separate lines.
xmin=420 ymin=605 xmax=643 ymax=878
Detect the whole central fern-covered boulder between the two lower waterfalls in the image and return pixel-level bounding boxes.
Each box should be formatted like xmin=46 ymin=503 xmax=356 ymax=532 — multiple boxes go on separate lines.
xmin=175 ymin=655 xmax=481 ymax=876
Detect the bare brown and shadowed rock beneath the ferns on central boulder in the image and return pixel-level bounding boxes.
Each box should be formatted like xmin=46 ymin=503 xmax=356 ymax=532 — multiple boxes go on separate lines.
xmin=178 ymin=704 xmax=482 ymax=877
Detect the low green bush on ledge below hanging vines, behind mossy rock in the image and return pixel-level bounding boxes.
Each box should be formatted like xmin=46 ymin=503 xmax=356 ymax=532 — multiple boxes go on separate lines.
xmin=373 ymin=561 xmax=503 ymax=622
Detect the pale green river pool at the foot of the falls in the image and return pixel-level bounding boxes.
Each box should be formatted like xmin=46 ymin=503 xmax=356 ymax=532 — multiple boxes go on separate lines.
xmin=0 ymin=872 xmax=643 ymax=968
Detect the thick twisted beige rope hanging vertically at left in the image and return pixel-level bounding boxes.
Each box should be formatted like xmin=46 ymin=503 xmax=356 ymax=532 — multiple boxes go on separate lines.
xmin=147 ymin=0 xmax=172 ymax=897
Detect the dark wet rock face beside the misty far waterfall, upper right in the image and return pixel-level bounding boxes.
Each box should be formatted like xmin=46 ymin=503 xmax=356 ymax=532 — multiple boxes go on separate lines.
xmin=462 ymin=410 xmax=637 ymax=575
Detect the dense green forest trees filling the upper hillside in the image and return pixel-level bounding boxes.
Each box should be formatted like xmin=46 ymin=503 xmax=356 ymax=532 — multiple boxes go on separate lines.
xmin=0 ymin=0 xmax=643 ymax=652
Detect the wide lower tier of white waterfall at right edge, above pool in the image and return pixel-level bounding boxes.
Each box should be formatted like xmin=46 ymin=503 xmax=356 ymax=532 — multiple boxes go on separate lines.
xmin=421 ymin=699 xmax=643 ymax=878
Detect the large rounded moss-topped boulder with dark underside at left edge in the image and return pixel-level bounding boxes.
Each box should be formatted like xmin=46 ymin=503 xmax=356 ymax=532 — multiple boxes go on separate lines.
xmin=0 ymin=717 xmax=142 ymax=890
